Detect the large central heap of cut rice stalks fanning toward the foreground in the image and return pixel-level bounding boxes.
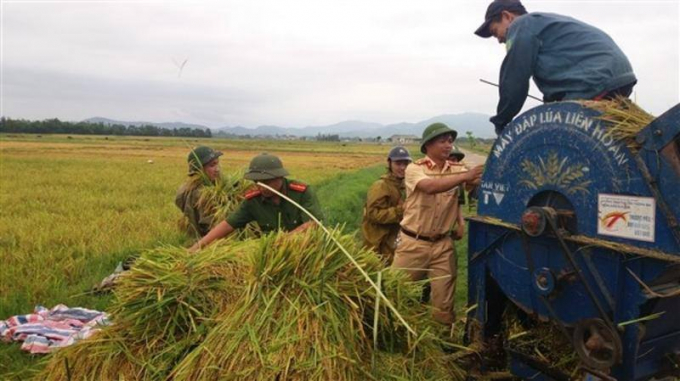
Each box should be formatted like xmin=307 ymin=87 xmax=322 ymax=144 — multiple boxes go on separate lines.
xmin=171 ymin=229 xmax=462 ymax=381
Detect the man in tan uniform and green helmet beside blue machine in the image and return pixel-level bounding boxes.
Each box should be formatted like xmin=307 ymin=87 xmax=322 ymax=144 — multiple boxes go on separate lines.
xmin=392 ymin=123 xmax=483 ymax=324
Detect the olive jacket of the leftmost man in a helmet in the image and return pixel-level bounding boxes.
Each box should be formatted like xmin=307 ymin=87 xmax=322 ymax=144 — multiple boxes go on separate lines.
xmin=175 ymin=178 xmax=213 ymax=237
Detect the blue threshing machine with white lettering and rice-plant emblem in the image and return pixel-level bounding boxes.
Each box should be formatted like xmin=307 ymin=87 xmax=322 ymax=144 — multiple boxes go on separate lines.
xmin=467 ymin=102 xmax=680 ymax=381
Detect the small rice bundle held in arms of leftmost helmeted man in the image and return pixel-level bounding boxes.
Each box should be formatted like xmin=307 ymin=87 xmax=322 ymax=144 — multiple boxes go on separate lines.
xmin=179 ymin=172 xmax=261 ymax=239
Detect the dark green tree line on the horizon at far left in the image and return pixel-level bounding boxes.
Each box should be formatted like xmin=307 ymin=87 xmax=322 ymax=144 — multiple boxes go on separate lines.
xmin=0 ymin=117 xmax=212 ymax=138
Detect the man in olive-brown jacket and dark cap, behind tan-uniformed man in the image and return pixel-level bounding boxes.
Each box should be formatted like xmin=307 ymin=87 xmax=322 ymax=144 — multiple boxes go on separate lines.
xmin=361 ymin=147 xmax=412 ymax=266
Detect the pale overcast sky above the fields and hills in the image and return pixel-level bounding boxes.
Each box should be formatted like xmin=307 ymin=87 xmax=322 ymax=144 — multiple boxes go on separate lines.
xmin=0 ymin=0 xmax=680 ymax=128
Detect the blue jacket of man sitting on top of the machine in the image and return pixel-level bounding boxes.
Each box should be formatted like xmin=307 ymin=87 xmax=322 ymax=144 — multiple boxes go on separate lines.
xmin=490 ymin=12 xmax=637 ymax=132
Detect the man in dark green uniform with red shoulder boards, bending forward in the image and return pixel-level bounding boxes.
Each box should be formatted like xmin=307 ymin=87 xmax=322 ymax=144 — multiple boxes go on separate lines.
xmin=190 ymin=153 xmax=322 ymax=251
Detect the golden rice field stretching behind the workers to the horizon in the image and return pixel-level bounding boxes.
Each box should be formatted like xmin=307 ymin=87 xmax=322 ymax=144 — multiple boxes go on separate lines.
xmin=0 ymin=135 xmax=480 ymax=379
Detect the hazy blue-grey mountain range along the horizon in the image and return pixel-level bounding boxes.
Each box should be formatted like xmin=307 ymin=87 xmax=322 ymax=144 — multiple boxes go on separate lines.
xmin=84 ymin=113 xmax=495 ymax=139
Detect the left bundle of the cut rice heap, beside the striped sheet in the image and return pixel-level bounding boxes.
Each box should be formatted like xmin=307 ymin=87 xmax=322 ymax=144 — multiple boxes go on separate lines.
xmin=36 ymin=241 xmax=252 ymax=381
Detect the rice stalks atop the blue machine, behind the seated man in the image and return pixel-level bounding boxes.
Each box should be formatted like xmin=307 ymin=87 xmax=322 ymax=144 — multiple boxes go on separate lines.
xmin=581 ymin=97 xmax=654 ymax=153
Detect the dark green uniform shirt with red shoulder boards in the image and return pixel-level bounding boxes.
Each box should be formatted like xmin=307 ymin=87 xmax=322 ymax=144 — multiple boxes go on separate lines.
xmin=227 ymin=178 xmax=322 ymax=233
